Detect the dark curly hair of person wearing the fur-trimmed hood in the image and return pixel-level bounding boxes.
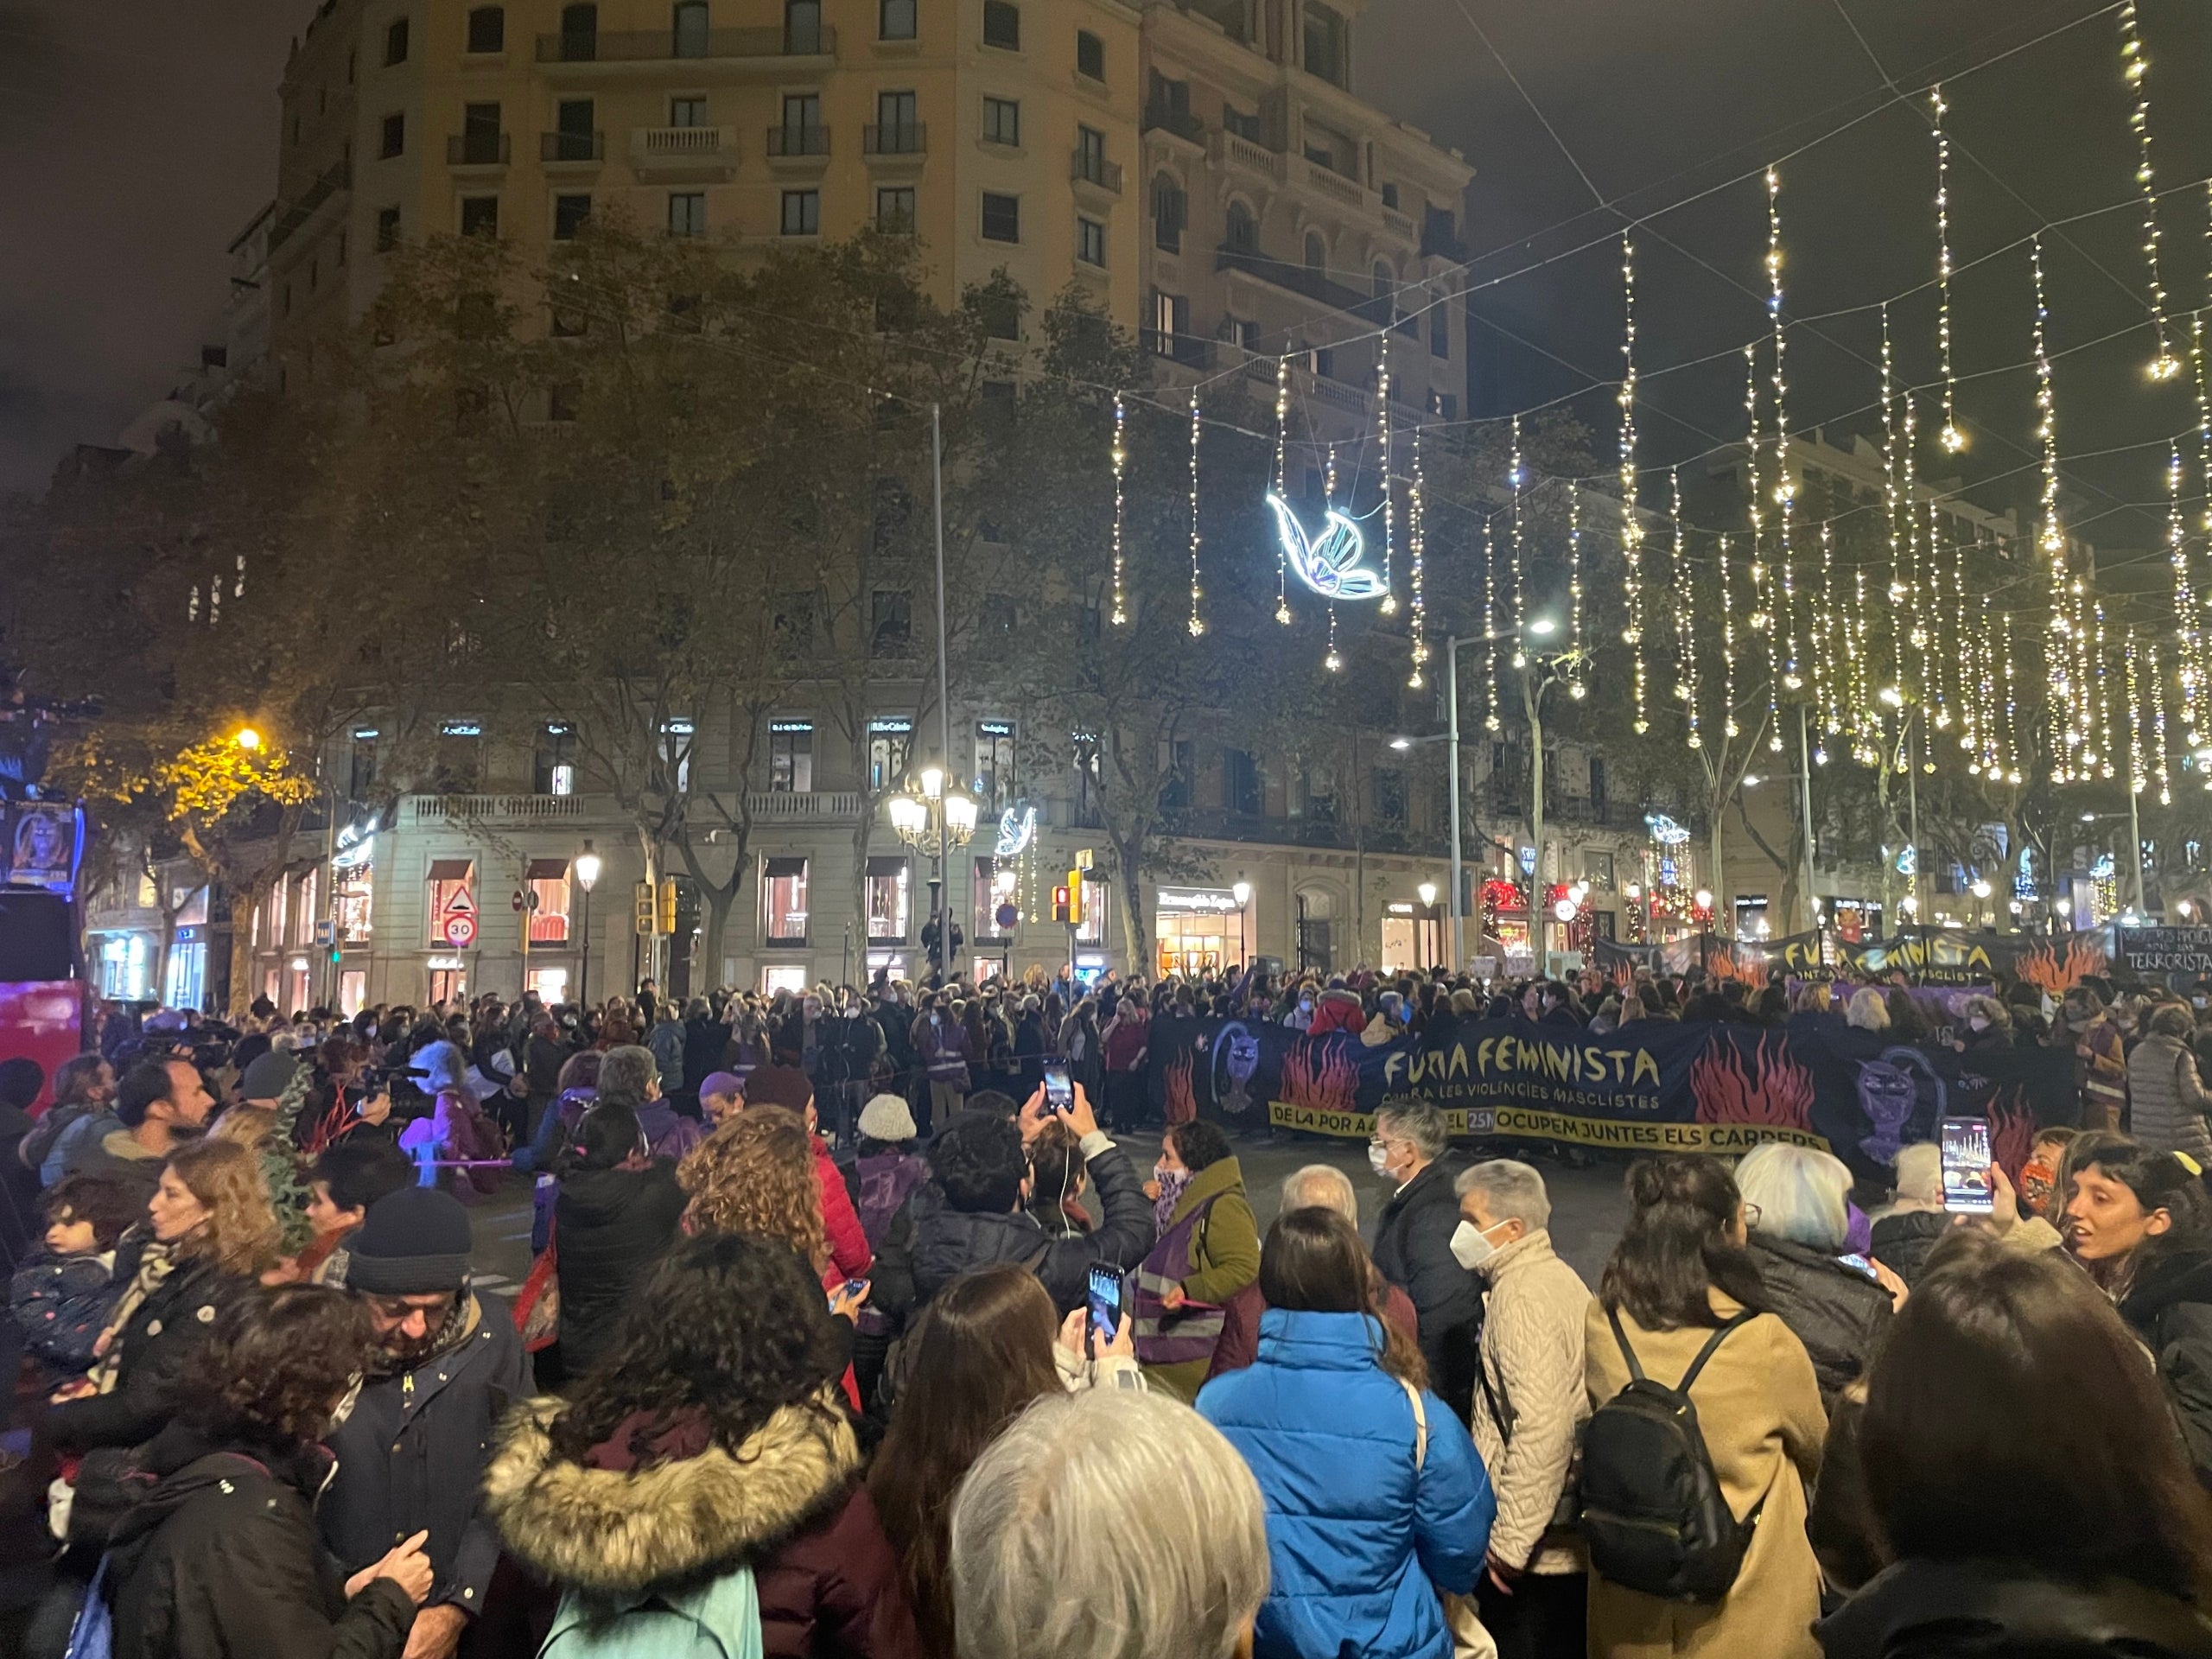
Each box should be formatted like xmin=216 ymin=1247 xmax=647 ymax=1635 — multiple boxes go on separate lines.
xmin=553 ymin=1232 xmax=845 ymax=1462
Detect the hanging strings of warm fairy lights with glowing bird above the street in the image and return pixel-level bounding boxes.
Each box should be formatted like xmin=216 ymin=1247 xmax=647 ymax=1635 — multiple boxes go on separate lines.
xmin=1065 ymin=0 xmax=2212 ymax=801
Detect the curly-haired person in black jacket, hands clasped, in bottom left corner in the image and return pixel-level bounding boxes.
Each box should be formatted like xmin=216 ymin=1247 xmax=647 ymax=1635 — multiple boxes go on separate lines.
xmin=104 ymin=1285 xmax=431 ymax=1659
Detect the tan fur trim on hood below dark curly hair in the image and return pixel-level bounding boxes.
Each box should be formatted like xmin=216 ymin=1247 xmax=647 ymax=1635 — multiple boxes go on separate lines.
xmin=485 ymin=1395 xmax=861 ymax=1595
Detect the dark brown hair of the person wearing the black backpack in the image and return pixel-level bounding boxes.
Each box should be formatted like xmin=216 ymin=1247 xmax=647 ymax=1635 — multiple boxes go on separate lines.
xmin=1597 ymin=1153 xmax=1765 ymax=1332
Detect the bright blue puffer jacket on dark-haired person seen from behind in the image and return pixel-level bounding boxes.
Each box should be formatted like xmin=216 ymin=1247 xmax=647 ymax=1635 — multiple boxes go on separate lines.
xmin=1199 ymin=1307 xmax=1497 ymax=1659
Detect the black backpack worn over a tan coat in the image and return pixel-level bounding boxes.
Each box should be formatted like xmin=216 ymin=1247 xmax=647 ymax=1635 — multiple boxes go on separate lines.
xmin=1581 ymin=1310 xmax=1765 ymax=1601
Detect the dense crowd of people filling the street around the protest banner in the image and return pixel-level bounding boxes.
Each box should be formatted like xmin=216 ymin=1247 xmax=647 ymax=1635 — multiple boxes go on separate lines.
xmin=0 ymin=973 xmax=2212 ymax=1659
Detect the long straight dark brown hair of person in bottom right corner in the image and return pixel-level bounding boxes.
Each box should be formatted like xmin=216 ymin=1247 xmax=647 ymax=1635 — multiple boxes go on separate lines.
xmin=1858 ymin=1241 xmax=2212 ymax=1601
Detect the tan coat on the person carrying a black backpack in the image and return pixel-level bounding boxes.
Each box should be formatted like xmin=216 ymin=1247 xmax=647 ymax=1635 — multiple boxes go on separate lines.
xmin=1586 ymin=1292 xmax=1827 ymax=1659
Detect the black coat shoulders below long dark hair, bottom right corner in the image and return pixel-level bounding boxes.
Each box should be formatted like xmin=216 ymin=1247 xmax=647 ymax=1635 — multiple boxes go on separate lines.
xmin=1812 ymin=1561 xmax=2212 ymax=1659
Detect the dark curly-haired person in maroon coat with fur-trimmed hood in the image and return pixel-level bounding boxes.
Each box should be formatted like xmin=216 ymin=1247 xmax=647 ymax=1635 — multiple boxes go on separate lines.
xmin=485 ymin=1232 xmax=920 ymax=1659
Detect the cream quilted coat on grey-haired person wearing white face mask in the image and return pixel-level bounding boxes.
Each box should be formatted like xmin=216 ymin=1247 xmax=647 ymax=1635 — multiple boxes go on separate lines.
xmin=1476 ymin=1230 xmax=1591 ymax=1573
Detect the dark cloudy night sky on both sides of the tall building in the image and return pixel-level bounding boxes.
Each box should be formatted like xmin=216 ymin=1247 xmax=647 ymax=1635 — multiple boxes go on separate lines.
xmin=0 ymin=0 xmax=2212 ymax=570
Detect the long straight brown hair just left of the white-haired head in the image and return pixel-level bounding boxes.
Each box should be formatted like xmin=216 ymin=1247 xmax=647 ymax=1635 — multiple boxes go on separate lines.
xmin=868 ymin=1265 xmax=1059 ymax=1659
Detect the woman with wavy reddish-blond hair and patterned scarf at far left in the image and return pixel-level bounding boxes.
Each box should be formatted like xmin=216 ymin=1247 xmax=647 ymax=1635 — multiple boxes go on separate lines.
xmin=44 ymin=1139 xmax=279 ymax=1451
